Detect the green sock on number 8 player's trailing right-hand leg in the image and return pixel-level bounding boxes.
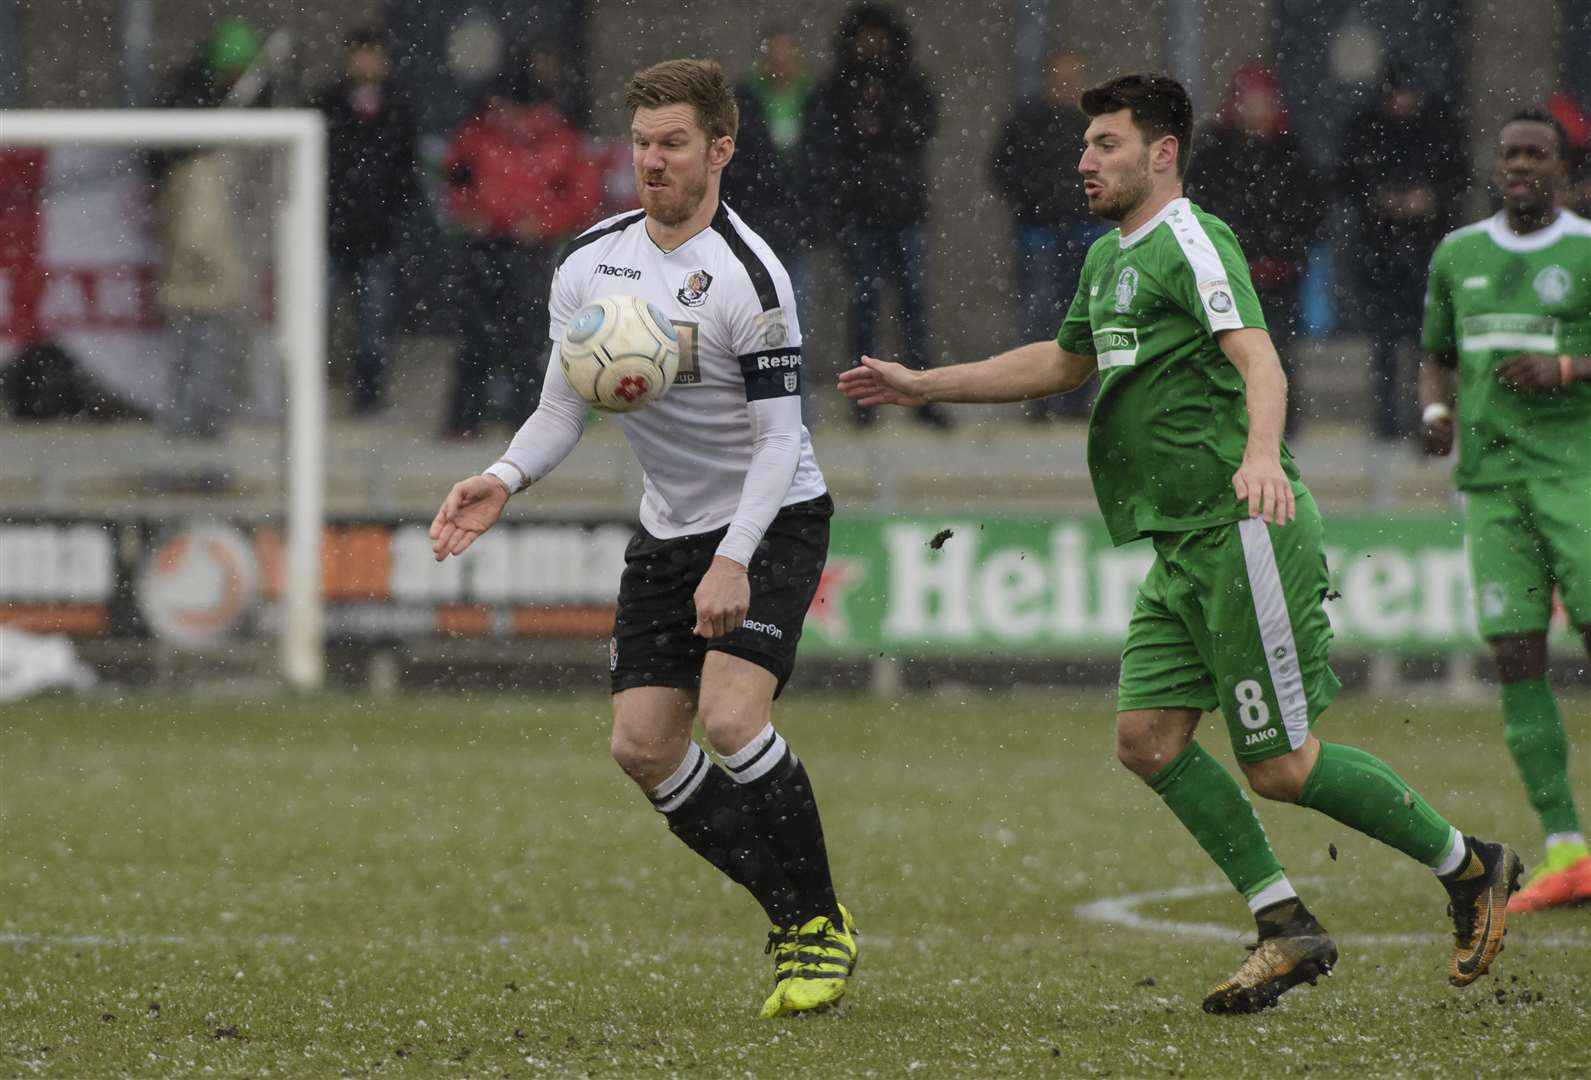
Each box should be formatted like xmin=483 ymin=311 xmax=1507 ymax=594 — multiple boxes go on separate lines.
xmin=1298 ymin=743 xmax=1453 ymax=867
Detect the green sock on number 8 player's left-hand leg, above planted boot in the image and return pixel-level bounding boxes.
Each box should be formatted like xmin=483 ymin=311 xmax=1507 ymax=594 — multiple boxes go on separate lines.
xmin=1149 ymin=743 xmax=1284 ymax=899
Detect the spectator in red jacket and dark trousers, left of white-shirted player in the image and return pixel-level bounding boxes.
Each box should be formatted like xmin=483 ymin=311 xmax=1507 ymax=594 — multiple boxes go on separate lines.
xmin=442 ymin=64 xmax=601 ymax=439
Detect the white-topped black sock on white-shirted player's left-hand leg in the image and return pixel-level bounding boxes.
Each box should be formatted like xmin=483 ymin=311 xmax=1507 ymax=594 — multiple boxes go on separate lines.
xmin=648 ymin=743 xmax=799 ymax=926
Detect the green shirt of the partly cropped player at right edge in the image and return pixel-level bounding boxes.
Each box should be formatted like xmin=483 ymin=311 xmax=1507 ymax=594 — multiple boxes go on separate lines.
xmin=1422 ymin=210 xmax=1591 ymax=490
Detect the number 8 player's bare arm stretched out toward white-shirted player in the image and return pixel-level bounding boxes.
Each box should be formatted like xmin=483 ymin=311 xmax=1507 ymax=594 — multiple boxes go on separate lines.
xmin=840 ymin=340 xmax=1095 ymax=406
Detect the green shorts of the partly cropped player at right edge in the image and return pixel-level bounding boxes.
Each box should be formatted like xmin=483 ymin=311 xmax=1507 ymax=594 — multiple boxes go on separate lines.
xmin=1464 ymin=476 xmax=1591 ymax=639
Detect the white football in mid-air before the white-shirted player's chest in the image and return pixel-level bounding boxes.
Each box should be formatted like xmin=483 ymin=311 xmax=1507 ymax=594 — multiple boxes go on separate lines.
xmin=558 ymin=293 xmax=679 ymax=412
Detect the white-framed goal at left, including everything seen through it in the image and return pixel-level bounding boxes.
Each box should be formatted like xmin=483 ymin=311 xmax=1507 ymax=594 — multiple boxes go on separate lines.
xmin=0 ymin=110 xmax=326 ymax=689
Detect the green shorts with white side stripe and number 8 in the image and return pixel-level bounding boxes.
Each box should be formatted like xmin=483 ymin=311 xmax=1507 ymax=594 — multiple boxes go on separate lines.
xmin=1117 ymin=488 xmax=1341 ymax=762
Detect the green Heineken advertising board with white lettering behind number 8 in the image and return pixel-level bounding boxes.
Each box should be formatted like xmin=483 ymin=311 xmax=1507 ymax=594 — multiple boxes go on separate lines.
xmin=802 ymin=515 xmax=1562 ymax=654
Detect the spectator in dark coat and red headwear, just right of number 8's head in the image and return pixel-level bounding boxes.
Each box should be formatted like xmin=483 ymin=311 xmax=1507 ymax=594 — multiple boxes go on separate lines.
xmin=1192 ymin=64 xmax=1327 ymax=434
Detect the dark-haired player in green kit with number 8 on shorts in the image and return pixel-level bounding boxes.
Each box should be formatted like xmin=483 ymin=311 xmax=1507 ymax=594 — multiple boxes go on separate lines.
xmin=840 ymin=75 xmax=1521 ymax=1013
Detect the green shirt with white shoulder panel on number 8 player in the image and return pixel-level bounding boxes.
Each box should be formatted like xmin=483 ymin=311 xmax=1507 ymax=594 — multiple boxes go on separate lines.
xmin=1056 ymin=199 xmax=1298 ymax=544
